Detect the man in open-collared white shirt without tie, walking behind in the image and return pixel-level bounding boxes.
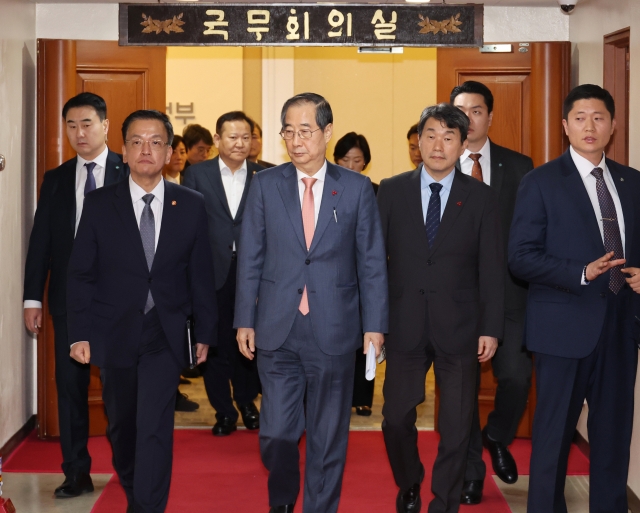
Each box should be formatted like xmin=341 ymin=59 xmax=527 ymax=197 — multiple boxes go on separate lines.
xmin=183 ymin=111 xmax=262 ymax=436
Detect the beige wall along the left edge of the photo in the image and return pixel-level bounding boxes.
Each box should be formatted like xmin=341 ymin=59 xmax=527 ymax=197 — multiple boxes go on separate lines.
xmin=0 ymin=0 xmax=36 ymax=446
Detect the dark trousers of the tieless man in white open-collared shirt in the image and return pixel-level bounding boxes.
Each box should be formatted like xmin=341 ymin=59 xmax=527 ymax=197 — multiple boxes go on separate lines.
xmin=202 ymin=255 xmax=260 ymax=421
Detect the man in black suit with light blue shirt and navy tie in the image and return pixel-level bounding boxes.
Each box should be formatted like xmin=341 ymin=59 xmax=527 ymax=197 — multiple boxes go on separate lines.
xmin=378 ymin=103 xmax=504 ymax=513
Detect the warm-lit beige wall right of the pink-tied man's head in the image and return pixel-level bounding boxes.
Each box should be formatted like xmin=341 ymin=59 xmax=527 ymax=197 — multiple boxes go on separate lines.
xmin=294 ymin=48 xmax=436 ymax=182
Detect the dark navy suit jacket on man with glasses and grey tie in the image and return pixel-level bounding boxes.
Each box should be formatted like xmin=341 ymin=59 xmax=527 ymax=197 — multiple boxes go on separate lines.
xmin=67 ymin=180 xmax=218 ymax=368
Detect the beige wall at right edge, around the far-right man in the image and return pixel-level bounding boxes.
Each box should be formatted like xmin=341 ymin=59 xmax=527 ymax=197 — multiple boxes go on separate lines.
xmin=569 ymin=0 xmax=640 ymax=496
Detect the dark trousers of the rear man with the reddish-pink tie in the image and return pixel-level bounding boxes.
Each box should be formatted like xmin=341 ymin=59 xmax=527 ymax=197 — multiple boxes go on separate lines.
xmin=464 ymin=317 xmax=533 ymax=481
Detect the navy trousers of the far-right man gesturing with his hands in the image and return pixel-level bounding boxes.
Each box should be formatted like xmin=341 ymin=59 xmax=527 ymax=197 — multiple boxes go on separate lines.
xmin=527 ymin=288 xmax=638 ymax=513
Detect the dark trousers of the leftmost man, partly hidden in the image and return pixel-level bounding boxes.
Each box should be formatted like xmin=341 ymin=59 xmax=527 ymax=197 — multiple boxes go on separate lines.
xmin=52 ymin=315 xmax=91 ymax=476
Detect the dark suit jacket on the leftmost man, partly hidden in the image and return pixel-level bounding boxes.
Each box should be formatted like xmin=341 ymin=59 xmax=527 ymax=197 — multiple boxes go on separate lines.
xmin=23 ymin=151 xmax=129 ymax=315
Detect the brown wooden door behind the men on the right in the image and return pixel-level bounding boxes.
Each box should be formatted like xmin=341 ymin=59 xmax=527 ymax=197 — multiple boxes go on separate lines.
xmin=435 ymin=42 xmax=570 ymax=437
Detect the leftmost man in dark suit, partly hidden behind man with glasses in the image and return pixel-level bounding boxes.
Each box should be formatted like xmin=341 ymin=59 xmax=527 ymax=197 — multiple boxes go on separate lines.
xmin=24 ymin=93 xmax=128 ymax=498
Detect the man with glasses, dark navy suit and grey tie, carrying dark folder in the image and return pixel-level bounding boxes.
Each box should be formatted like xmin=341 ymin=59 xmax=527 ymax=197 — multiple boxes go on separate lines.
xmin=67 ymin=110 xmax=217 ymax=513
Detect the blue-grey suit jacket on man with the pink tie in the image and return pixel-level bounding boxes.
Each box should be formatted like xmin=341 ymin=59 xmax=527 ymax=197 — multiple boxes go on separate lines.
xmin=234 ymin=163 xmax=388 ymax=355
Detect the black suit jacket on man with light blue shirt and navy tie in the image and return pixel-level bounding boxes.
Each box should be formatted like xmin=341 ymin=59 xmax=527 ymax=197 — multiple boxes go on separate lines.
xmin=378 ymin=166 xmax=505 ymax=354
